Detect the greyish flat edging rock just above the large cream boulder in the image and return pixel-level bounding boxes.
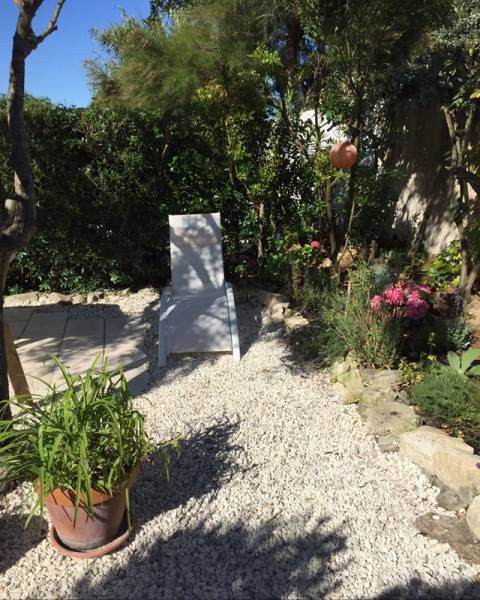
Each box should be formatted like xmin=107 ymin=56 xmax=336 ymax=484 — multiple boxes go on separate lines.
xmin=359 ymin=400 xmax=419 ymax=436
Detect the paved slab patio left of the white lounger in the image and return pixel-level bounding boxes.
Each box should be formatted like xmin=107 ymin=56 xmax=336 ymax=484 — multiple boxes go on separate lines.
xmin=5 ymin=307 xmax=150 ymax=395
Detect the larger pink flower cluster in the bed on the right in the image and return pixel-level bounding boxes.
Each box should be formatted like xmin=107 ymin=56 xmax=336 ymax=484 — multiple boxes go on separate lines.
xmin=370 ymin=282 xmax=432 ymax=321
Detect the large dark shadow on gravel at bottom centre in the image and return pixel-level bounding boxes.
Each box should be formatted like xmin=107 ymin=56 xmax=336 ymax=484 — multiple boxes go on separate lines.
xmin=73 ymin=518 xmax=345 ymax=600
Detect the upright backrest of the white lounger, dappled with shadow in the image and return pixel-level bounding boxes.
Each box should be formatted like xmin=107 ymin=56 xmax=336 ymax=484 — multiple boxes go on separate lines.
xmin=169 ymin=213 xmax=225 ymax=296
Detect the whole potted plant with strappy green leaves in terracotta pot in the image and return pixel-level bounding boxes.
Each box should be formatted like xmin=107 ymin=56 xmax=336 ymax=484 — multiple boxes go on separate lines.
xmin=0 ymin=357 xmax=178 ymax=558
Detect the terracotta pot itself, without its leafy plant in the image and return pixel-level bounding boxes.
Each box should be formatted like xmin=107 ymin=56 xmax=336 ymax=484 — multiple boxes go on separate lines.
xmin=41 ymin=465 xmax=140 ymax=551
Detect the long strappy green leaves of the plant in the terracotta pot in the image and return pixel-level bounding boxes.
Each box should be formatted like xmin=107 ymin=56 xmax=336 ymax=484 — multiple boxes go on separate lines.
xmin=0 ymin=358 xmax=175 ymax=518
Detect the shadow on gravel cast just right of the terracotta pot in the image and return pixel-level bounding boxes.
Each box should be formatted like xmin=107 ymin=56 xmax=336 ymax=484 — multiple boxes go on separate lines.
xmin=133 ymin=422 xmax=241 ymax=526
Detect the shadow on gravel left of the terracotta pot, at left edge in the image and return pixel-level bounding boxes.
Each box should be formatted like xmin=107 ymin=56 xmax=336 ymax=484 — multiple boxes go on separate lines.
xmin=0 ymin=514 xmax=48 ymax=574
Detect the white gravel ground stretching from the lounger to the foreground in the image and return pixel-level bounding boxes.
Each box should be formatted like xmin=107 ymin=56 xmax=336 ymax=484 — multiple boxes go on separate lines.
xmin=0 ymin=290 xmax=480 ymax=600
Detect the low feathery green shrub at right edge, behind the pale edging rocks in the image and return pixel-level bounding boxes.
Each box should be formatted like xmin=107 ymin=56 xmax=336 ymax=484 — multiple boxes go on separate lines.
xmin=412 ymin=365 xmax=480 ymax=431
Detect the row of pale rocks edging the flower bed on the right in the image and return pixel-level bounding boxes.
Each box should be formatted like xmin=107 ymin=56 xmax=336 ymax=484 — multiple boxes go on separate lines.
xmin=330 ymin=357 xmax=480 ymax=539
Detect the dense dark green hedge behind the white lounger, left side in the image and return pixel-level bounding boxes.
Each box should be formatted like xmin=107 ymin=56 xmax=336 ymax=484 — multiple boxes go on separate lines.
xmin=0 ymin=99 xmax=248 ymax=291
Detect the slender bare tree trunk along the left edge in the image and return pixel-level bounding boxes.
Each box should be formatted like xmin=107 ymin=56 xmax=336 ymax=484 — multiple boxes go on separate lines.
xmin=0 ymin=0 xmax=65 ymax=416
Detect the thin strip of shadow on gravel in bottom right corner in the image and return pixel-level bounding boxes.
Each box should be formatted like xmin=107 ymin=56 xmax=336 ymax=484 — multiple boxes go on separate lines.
xmin=365 ymin=577 xmax=480 ymax=600
